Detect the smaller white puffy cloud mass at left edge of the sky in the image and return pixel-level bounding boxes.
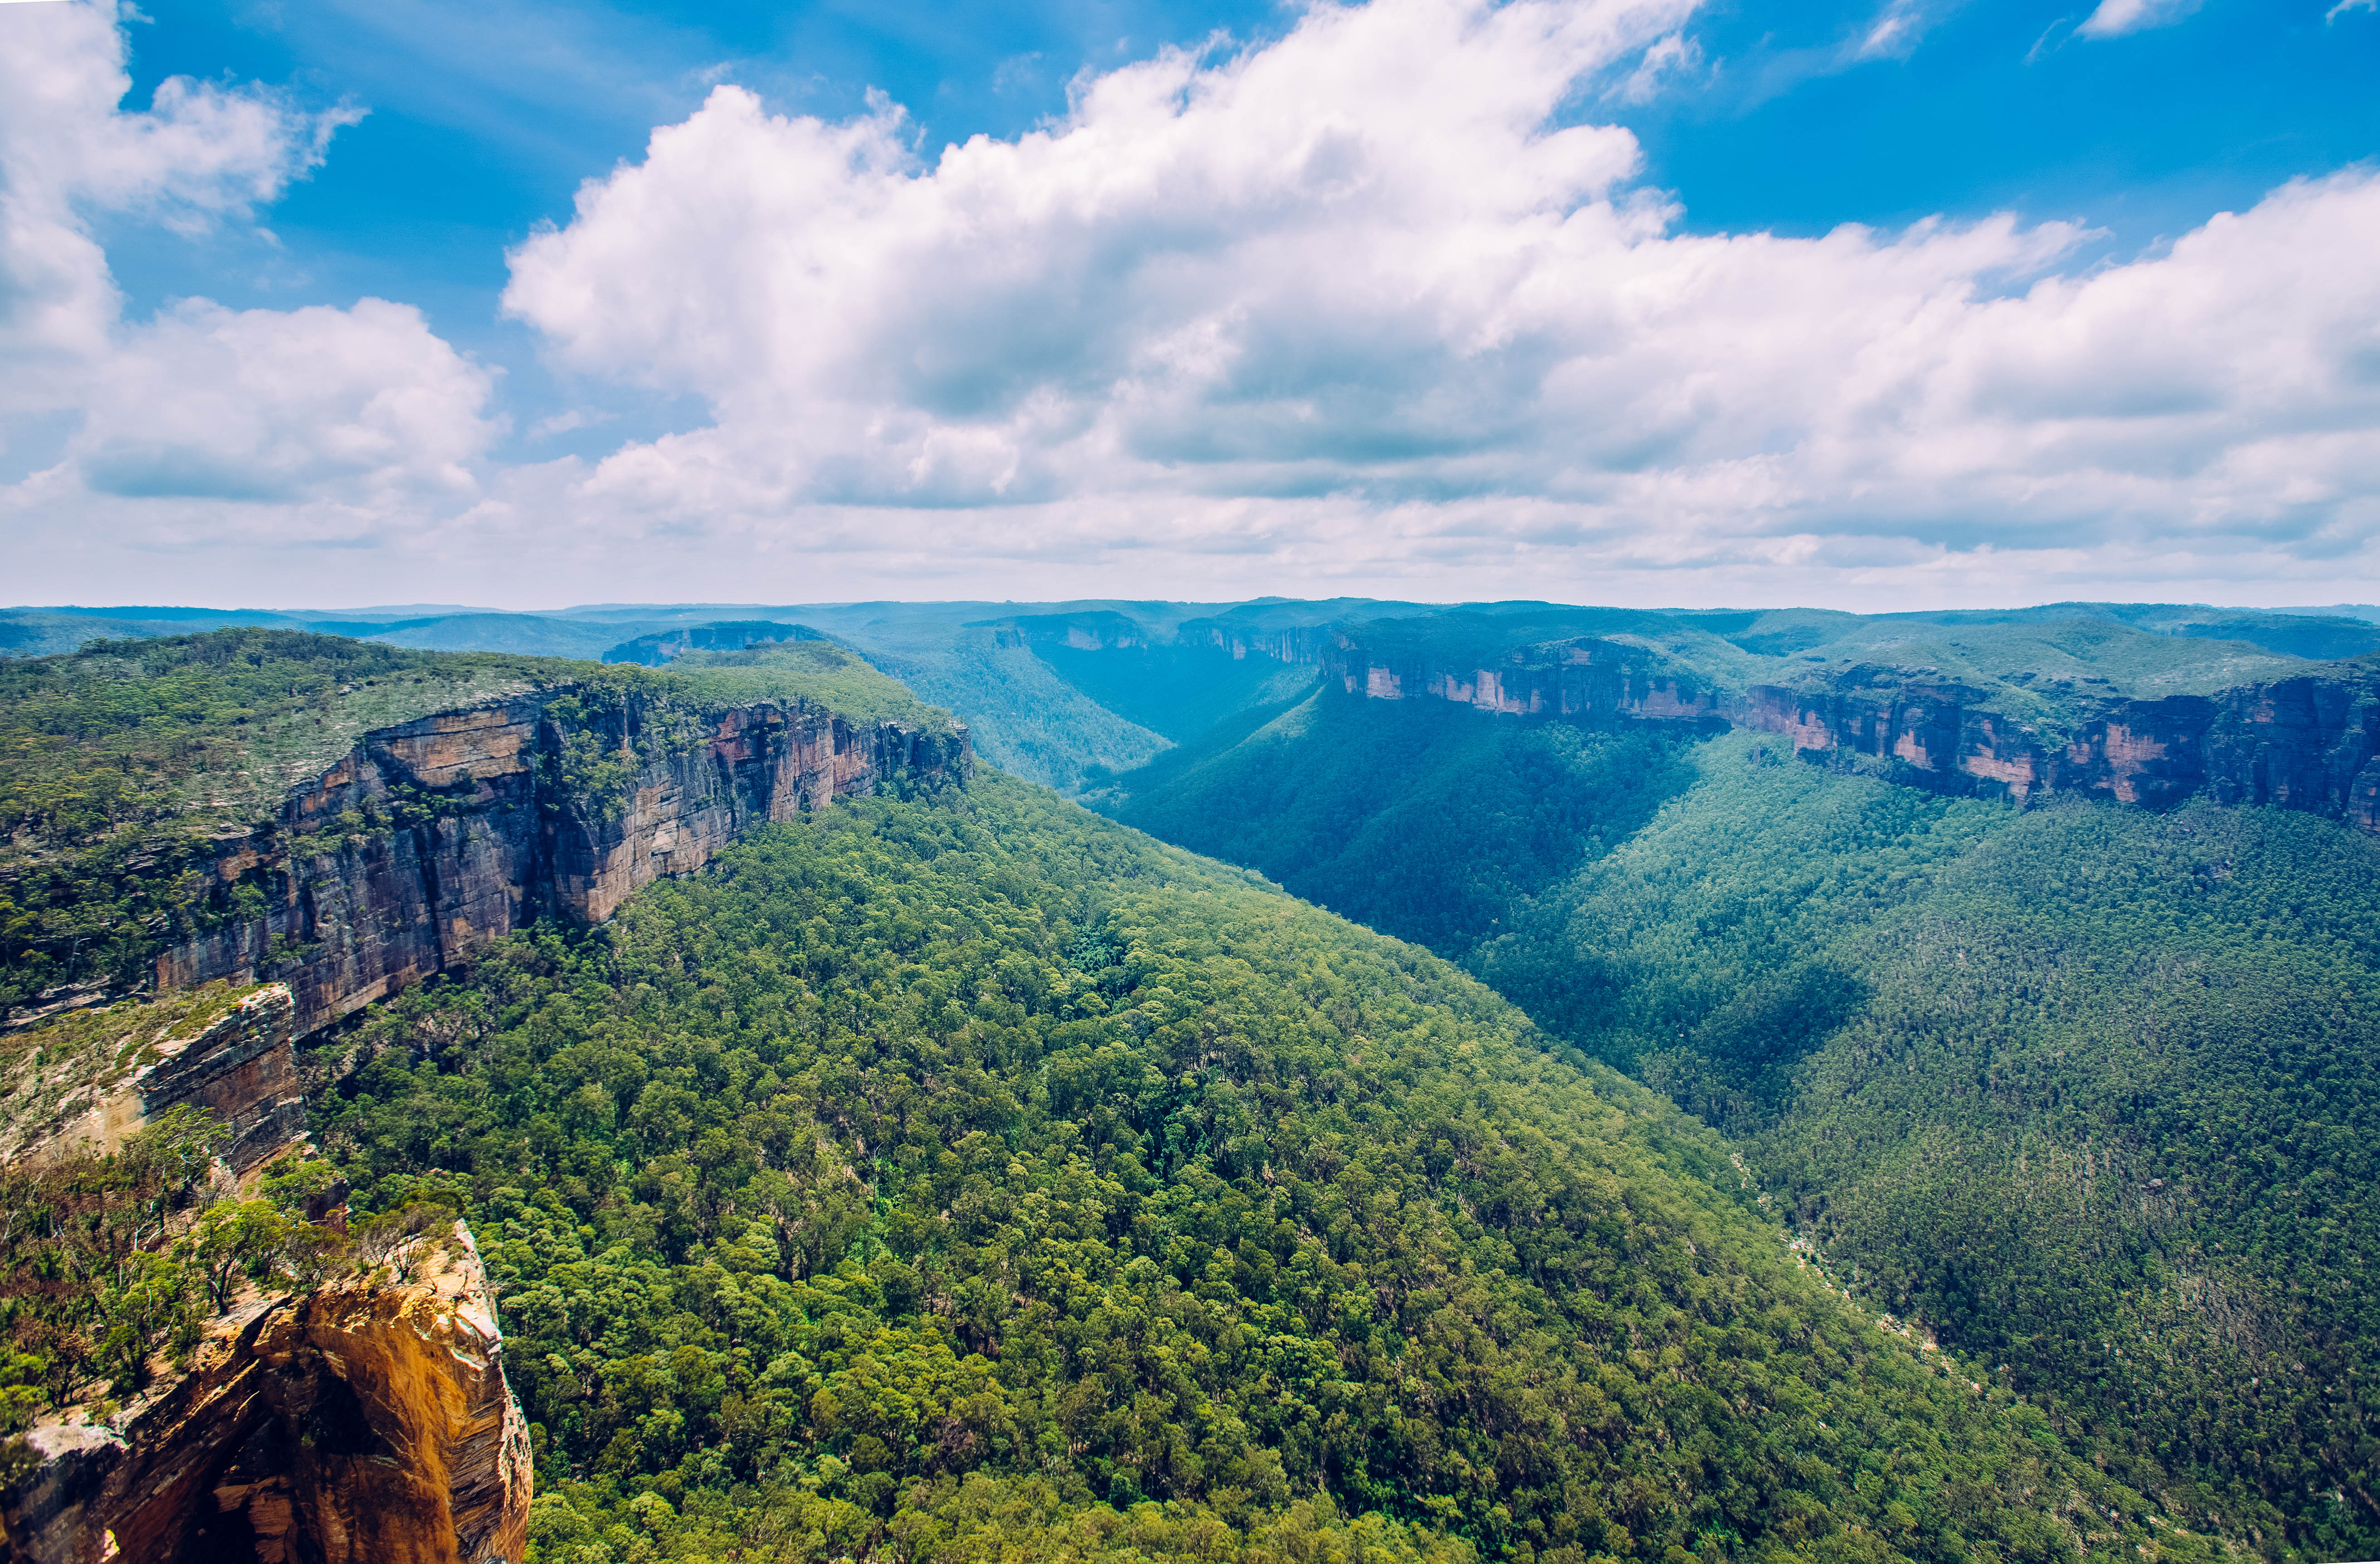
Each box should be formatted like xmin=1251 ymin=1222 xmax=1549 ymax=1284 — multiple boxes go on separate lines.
xmin=0 ymin=0 xmax=493 ymax=559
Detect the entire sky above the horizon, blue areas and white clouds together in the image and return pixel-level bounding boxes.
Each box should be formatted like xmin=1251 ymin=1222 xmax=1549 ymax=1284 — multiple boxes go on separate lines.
xmin=0 ymin=0 xmax=2380 ymax=610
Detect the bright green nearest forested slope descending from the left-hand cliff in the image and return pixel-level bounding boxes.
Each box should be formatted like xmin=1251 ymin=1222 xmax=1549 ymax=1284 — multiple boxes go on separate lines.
xmin=317 ymin=774 xmax=2211 ymax=1564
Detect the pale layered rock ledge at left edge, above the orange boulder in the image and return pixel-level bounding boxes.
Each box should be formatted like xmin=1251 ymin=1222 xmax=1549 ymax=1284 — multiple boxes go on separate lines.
xmin=0 ymin=983 xmax=305 ymax=1173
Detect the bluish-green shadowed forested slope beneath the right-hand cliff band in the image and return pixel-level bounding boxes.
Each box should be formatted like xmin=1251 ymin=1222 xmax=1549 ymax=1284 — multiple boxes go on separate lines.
xmin=1119 ymin=698 xmax=2380 ymax=1559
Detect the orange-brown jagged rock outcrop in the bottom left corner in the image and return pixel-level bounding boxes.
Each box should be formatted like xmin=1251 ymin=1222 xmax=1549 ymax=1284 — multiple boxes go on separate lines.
xmin=0 ymin=1224 xmax=531 ymax=1564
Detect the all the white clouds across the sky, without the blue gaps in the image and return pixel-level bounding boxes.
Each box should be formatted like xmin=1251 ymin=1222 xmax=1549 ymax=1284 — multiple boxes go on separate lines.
xmin=0 ymin=0 xmax=2380 ymax=605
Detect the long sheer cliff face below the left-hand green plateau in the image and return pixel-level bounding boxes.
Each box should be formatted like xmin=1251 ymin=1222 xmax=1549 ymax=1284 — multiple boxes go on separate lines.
xmin=157 ymin=690 xmax=973 ymax=1036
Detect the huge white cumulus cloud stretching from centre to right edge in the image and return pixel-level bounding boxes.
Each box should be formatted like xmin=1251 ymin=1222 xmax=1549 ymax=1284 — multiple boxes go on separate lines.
xmin=488 ymin=0 xmax=2380 ymax=591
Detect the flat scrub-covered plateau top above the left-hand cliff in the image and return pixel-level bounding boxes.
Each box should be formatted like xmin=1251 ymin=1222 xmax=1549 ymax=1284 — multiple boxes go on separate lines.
xmin=0 ymin=628 xmax=950 ymax=1019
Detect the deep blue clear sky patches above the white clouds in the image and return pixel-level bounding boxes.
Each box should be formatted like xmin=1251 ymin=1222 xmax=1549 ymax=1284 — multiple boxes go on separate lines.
xmin=112 ymin=0 xmax=2380 ymax=390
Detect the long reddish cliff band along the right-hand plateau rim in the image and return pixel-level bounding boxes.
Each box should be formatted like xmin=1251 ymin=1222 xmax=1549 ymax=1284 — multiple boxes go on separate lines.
xmin=1304 ymin=631 xmax=2380 ymax=831
